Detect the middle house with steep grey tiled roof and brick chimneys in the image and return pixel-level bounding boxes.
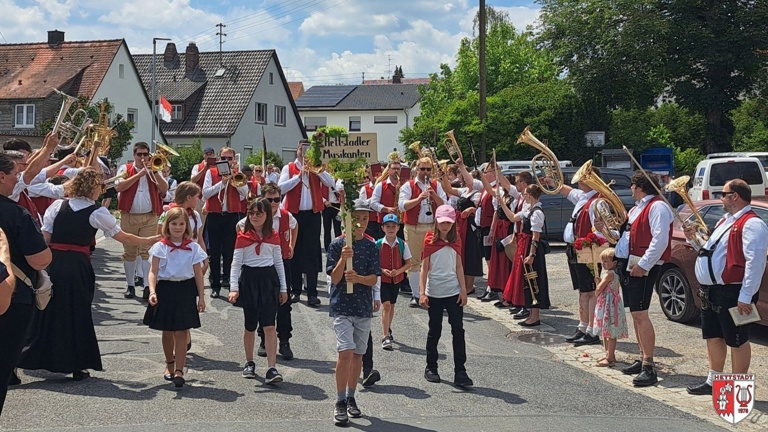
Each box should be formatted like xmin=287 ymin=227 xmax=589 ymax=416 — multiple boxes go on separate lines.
xmin=133 ymin=42 xmax=306 ymax=162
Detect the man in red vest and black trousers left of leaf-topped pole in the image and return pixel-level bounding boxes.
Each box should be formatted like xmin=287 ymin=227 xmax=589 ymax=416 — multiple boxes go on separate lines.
xmin=277 ymin=140 xmax=335 ymax=307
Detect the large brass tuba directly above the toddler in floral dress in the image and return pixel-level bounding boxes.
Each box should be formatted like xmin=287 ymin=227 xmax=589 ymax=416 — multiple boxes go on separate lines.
xmin=571 ymin=160 xmax=627 ymax=244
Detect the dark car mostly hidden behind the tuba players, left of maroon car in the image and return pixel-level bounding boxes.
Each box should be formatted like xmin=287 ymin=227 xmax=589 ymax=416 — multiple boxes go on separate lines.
xmin=502 ymin=167 xmax=635 ymax=241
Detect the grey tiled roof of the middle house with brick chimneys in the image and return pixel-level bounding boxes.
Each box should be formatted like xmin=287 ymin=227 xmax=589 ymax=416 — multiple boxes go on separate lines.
xmin=133 ymin=50 xmax=299 ymax=136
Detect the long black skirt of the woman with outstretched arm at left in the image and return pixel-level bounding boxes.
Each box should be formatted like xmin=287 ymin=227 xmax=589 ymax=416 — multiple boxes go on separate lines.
xmin=18 ymin=250 xmax=102 ymax=373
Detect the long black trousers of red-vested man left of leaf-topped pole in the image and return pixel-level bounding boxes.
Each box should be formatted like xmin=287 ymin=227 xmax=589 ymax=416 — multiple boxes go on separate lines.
xmin=291 ymin=210 xmax=322 ymax=297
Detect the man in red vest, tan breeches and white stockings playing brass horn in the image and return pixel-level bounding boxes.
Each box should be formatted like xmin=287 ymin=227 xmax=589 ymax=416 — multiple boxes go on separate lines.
xmin=115 ymin=142 xmax=168 ymax=300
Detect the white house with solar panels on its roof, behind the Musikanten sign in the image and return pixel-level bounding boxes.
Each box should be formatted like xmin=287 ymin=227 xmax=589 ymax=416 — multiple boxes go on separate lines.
xmin=296 ymin=83 xmax=421 ymax=163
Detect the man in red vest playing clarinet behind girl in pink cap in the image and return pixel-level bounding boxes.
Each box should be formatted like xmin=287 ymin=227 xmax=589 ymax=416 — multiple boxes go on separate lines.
xmin=398 ymin=157 xmax=448 ymax=308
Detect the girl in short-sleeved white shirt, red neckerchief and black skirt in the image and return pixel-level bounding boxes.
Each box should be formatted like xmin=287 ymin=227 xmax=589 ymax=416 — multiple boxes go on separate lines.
xmin=144 ymin=207 xmax=208 ymax=387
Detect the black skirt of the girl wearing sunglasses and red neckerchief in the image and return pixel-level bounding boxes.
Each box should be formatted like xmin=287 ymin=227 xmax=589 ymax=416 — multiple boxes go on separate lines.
xmin=235 ymin=265 xmax=280 ymax=310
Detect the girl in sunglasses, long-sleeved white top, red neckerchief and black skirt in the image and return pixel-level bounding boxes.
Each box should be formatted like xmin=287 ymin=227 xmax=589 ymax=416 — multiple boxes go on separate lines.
xmin=229 ymin=198 xmax=288 ymax=384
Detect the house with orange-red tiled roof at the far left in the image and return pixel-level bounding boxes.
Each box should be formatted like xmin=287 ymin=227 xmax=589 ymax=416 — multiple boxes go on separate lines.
xmin=0 ymin=30 xmax=162 ymax=151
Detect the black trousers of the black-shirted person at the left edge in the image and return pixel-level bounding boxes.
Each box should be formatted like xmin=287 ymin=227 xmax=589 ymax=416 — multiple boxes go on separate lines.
xmin=0 ymin=303 xmax=33 ymax=415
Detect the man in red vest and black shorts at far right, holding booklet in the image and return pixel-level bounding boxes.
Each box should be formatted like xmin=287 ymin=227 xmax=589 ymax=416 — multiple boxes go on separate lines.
xmin=685 ymin=179 xmax=768 ymax=395
